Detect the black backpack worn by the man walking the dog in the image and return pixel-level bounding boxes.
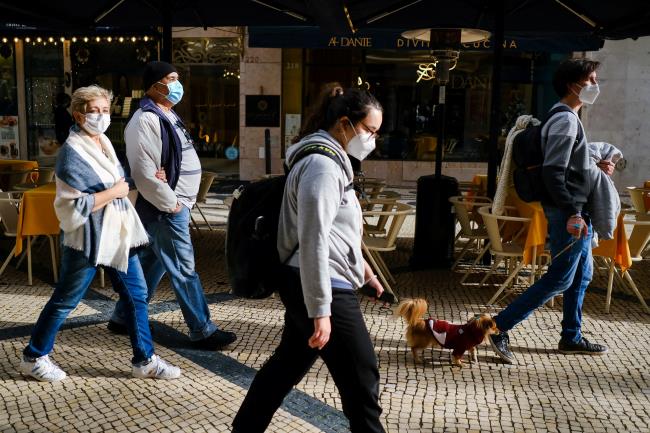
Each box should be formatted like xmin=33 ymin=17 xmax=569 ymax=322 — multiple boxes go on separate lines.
xmin=512 ymin=105 xmax=582 ymax=202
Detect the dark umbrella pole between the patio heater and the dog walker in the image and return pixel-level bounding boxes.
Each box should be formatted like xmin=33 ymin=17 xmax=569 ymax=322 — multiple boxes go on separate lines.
xmin=487 ymin=0 xmax=505 ymax=197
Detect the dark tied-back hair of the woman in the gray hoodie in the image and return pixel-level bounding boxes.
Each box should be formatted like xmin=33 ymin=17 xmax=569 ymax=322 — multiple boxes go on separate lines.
xmin=298 ymin=83 xmax=383 ymax=140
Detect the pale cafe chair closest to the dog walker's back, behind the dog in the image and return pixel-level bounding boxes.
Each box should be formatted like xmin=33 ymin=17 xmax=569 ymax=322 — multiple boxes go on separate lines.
xmin=478 ymin=205 xmax=531 ymax=304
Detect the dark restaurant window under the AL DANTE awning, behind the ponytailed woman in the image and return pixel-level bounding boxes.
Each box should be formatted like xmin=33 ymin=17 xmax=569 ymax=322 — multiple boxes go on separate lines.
xmin=296 ymin=49 xmax=566 ymax=161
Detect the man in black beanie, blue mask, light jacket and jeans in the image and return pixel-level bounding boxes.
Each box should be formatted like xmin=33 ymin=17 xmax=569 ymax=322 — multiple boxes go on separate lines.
xmin=108 ymin=61 xmax=237 ymax=350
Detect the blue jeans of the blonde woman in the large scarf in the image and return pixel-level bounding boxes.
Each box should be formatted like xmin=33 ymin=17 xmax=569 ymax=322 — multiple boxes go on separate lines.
xmin=23 ymin=247 xmax=154 ymax=364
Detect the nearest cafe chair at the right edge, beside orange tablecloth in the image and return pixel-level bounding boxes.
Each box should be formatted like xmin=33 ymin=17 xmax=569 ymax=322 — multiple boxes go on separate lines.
xmin=594 ymin=212 xmax=650 ymax=313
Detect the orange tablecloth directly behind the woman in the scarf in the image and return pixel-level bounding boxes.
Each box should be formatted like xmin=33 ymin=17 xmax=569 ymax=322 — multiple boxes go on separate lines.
xmin=16 ymin=183 xmax=60 ymax=256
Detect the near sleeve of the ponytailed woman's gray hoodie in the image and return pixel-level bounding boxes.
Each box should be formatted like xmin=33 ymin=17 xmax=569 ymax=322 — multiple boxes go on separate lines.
xmin=297 ymin=162 xmax=341 ymax=318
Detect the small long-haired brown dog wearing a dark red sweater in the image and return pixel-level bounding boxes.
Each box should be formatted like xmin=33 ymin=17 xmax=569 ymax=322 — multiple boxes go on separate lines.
xmin=395 ymin=298 xmax=499 ymax=367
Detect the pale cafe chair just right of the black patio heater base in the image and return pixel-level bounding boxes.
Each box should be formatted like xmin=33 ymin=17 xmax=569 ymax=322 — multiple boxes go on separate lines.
xmin=449 ymin=195 xmax=492 ymax=274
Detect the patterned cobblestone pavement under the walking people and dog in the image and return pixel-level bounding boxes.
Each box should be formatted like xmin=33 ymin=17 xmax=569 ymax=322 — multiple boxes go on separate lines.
xmin=0 ymin=194 xmax=650 ymax=432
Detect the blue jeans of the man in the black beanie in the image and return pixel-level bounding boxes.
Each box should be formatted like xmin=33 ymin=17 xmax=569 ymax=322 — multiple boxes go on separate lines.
xmin=111 ymin=206 xmax=217 ymax=341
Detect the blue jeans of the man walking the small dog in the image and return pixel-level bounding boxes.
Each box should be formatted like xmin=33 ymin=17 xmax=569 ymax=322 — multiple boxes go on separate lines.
xmin=494 ymin=207 xmax=593 ymax=343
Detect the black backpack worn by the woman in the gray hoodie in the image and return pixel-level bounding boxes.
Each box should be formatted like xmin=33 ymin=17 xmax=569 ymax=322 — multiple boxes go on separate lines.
xmin=226 ymin=144 xmax=340 ymax=299
